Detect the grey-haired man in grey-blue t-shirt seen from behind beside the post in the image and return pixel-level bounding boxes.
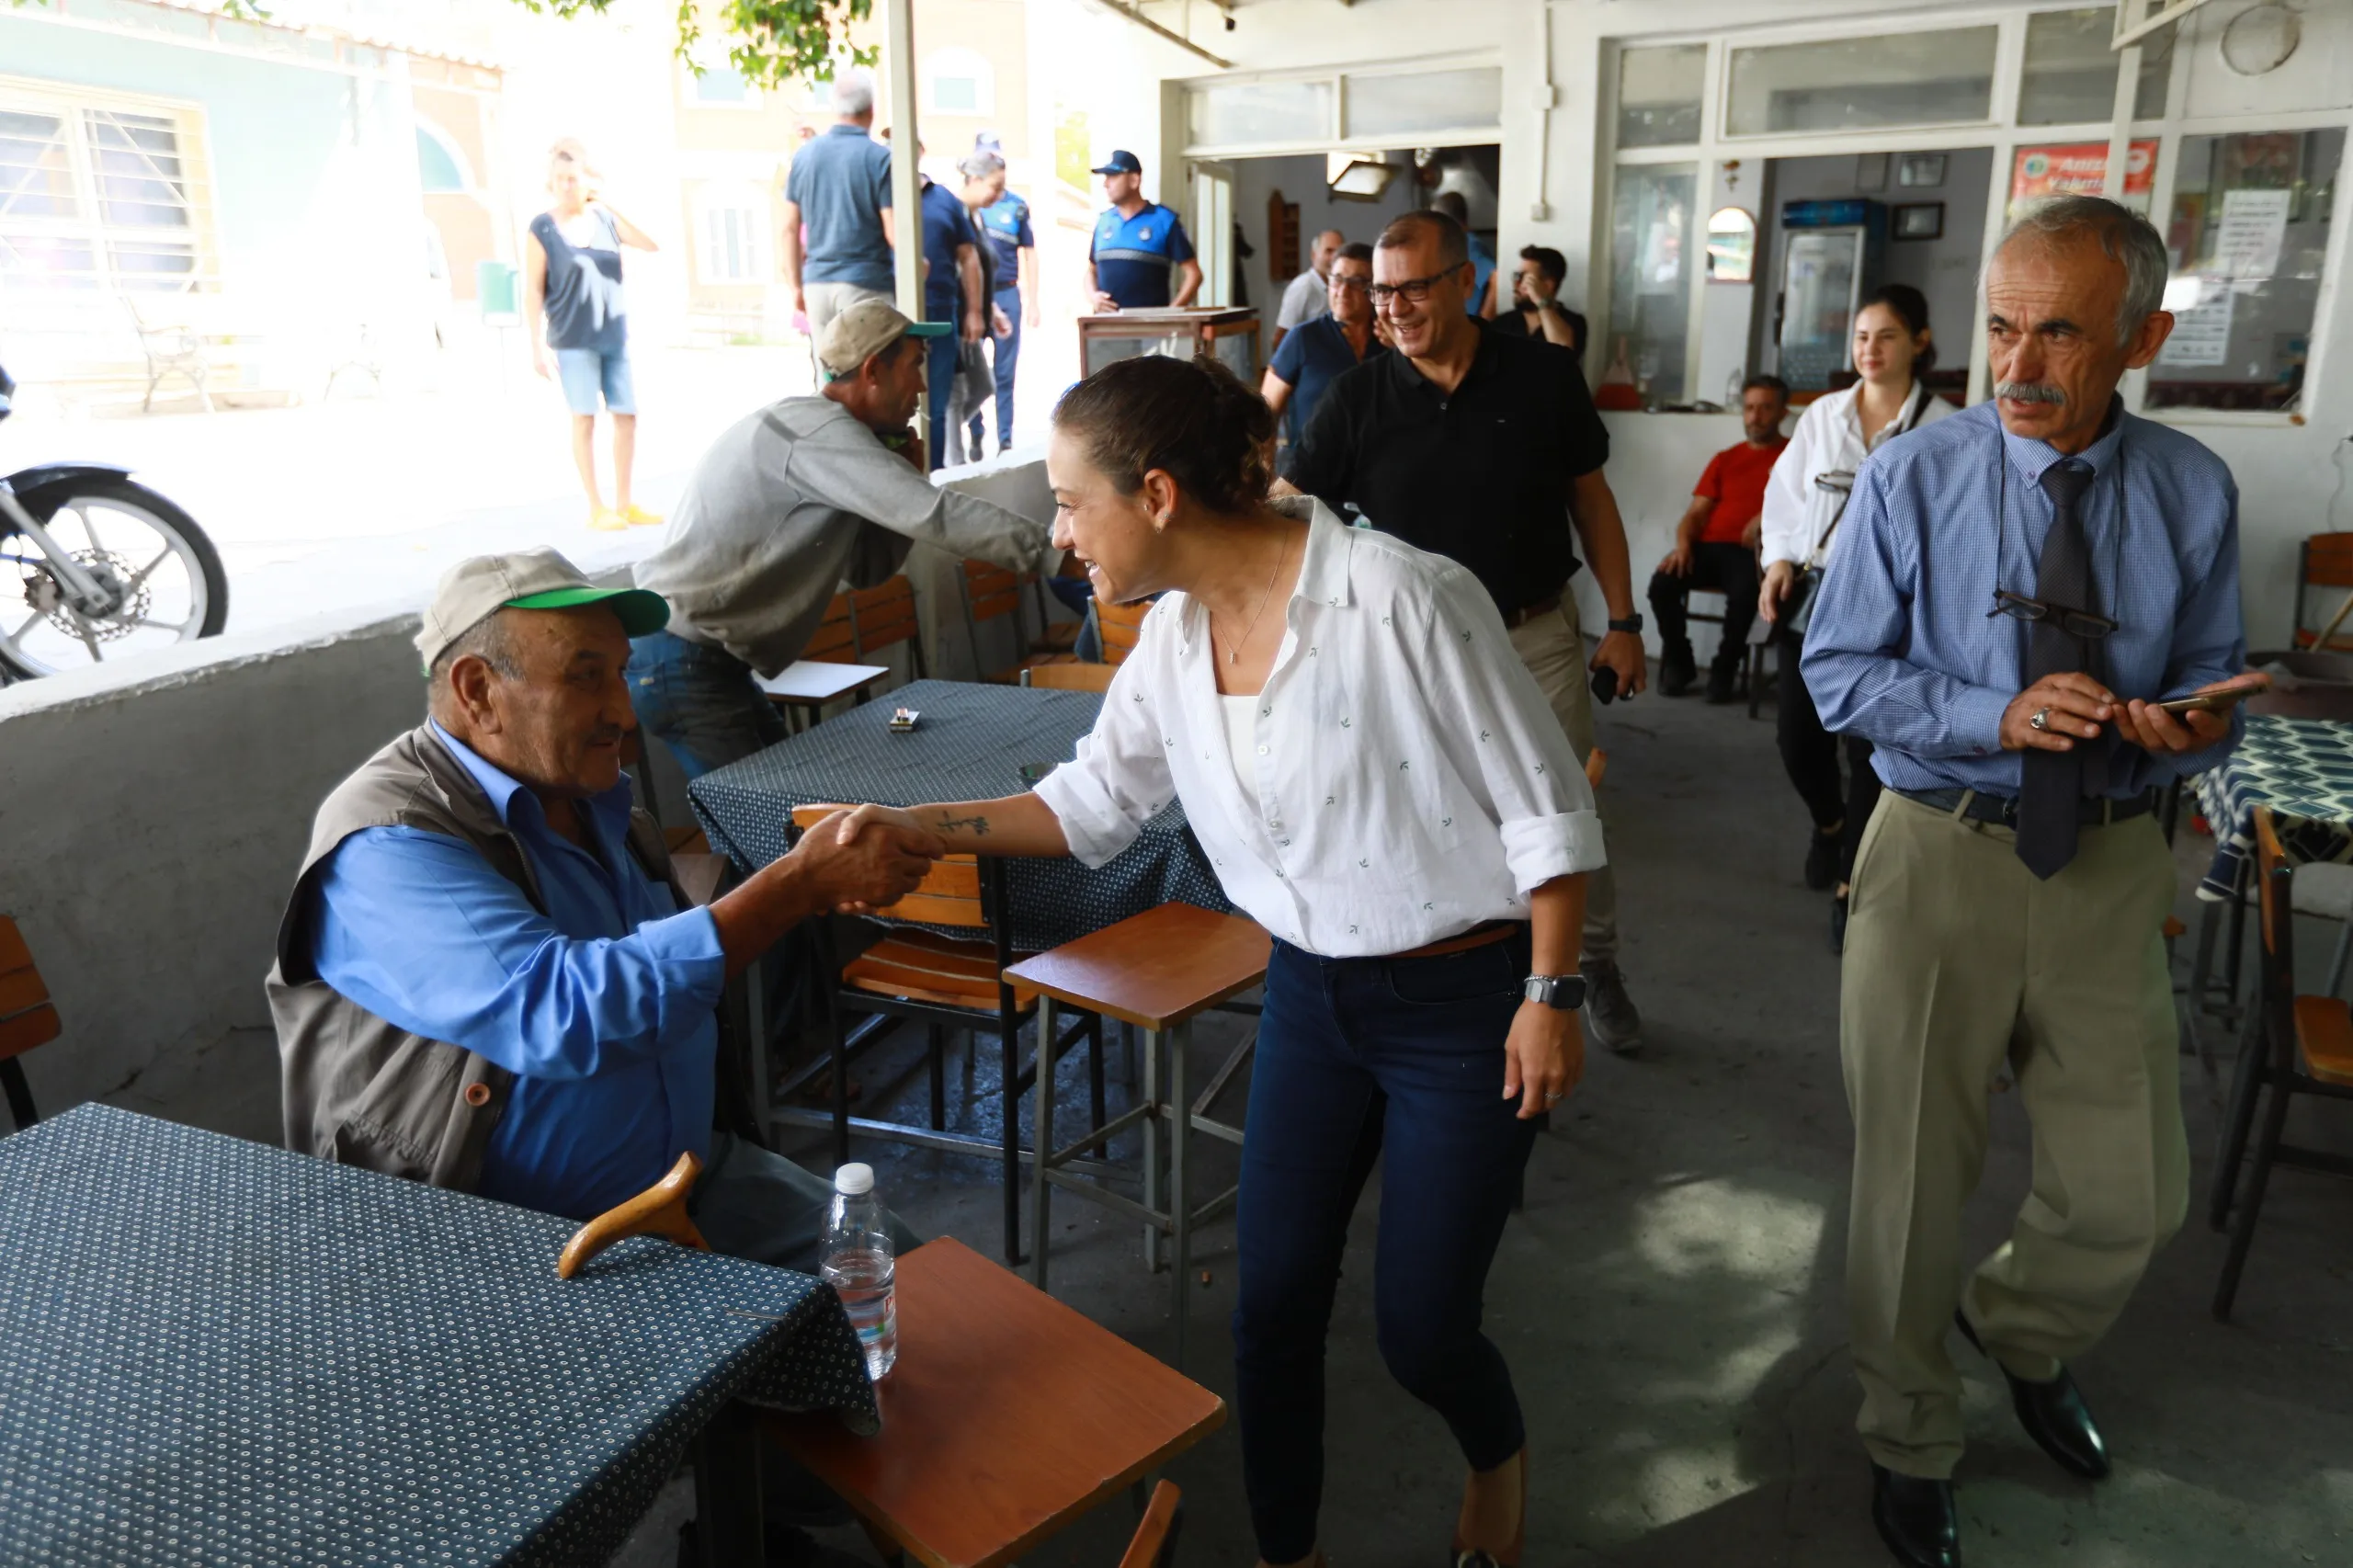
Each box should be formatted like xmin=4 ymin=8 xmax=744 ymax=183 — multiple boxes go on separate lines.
xmin=781 ymin=71 xmax=892 ymax=341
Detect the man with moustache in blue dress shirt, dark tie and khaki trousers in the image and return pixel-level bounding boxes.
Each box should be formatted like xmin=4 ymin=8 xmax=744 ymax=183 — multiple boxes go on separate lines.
xmin=1802 ymin=196 xmax=2247 ymax=1568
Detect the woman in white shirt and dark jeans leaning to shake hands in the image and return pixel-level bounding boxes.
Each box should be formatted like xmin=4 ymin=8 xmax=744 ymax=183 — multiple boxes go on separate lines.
xmin=842 ymin=356 xmax=1602 ymax=1568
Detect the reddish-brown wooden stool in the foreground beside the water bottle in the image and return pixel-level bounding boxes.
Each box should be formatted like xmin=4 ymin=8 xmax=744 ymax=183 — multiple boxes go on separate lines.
xmin=760 ymin=1236 xmax=1226 ymax=1568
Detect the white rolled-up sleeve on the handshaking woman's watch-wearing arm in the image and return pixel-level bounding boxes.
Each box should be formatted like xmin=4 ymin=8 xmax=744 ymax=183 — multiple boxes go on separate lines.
xmin=1421 ymin=567 xmax=1609 ymax=894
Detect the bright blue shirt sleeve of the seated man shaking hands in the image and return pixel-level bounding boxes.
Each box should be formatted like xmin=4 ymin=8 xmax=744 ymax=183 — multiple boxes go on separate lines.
xmin=311 ymin=826 xmax=727 ymax=1078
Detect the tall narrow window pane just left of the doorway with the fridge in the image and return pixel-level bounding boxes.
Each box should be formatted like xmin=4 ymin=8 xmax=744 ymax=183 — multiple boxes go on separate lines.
xmin=1602 ymin=163 xmax=1703 ymax=407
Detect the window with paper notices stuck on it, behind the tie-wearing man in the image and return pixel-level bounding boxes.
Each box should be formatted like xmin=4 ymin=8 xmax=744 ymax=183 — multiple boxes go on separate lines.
xmin=2148 ymin=127 xmax=2346 ymax=412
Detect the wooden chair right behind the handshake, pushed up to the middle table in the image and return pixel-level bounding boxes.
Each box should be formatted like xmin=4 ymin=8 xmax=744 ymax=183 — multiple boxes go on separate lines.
xmin=769 ymin=805 xmax=1104 ymax=1262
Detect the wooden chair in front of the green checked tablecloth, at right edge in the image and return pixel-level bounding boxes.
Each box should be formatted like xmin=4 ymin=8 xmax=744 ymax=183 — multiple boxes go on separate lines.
xmin=2210 ymin=805 xmax=2353 ymax=1324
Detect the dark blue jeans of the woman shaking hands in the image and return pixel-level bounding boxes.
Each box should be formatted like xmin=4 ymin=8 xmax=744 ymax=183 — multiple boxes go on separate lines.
xmin=1233 ymin=930 xmax=1537 ymax=1563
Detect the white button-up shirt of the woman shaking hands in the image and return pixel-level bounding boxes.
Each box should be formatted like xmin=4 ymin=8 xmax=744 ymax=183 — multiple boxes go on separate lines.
xmin=1038 ymin=496 xmax=1605 ymax=959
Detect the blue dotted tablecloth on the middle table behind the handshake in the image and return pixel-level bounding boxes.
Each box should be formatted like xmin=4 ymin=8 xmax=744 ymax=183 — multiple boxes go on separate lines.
xmin=688 ymin=680 xmax=1233 ymax=953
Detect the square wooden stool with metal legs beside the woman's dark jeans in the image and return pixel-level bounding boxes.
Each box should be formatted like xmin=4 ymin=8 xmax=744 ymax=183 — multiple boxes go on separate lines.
xmin=1005 ymin=904 xmax=1273 ymax=1368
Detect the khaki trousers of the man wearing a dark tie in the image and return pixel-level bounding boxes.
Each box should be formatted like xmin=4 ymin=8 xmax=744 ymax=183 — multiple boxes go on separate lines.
xmin=1837 ymin=793 xmax=2188 ymax=1476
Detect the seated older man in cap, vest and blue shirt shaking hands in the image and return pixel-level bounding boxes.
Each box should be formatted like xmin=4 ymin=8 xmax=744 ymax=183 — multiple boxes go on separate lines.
xmin=268 ymin=549 xmax=941 ymax=1269
